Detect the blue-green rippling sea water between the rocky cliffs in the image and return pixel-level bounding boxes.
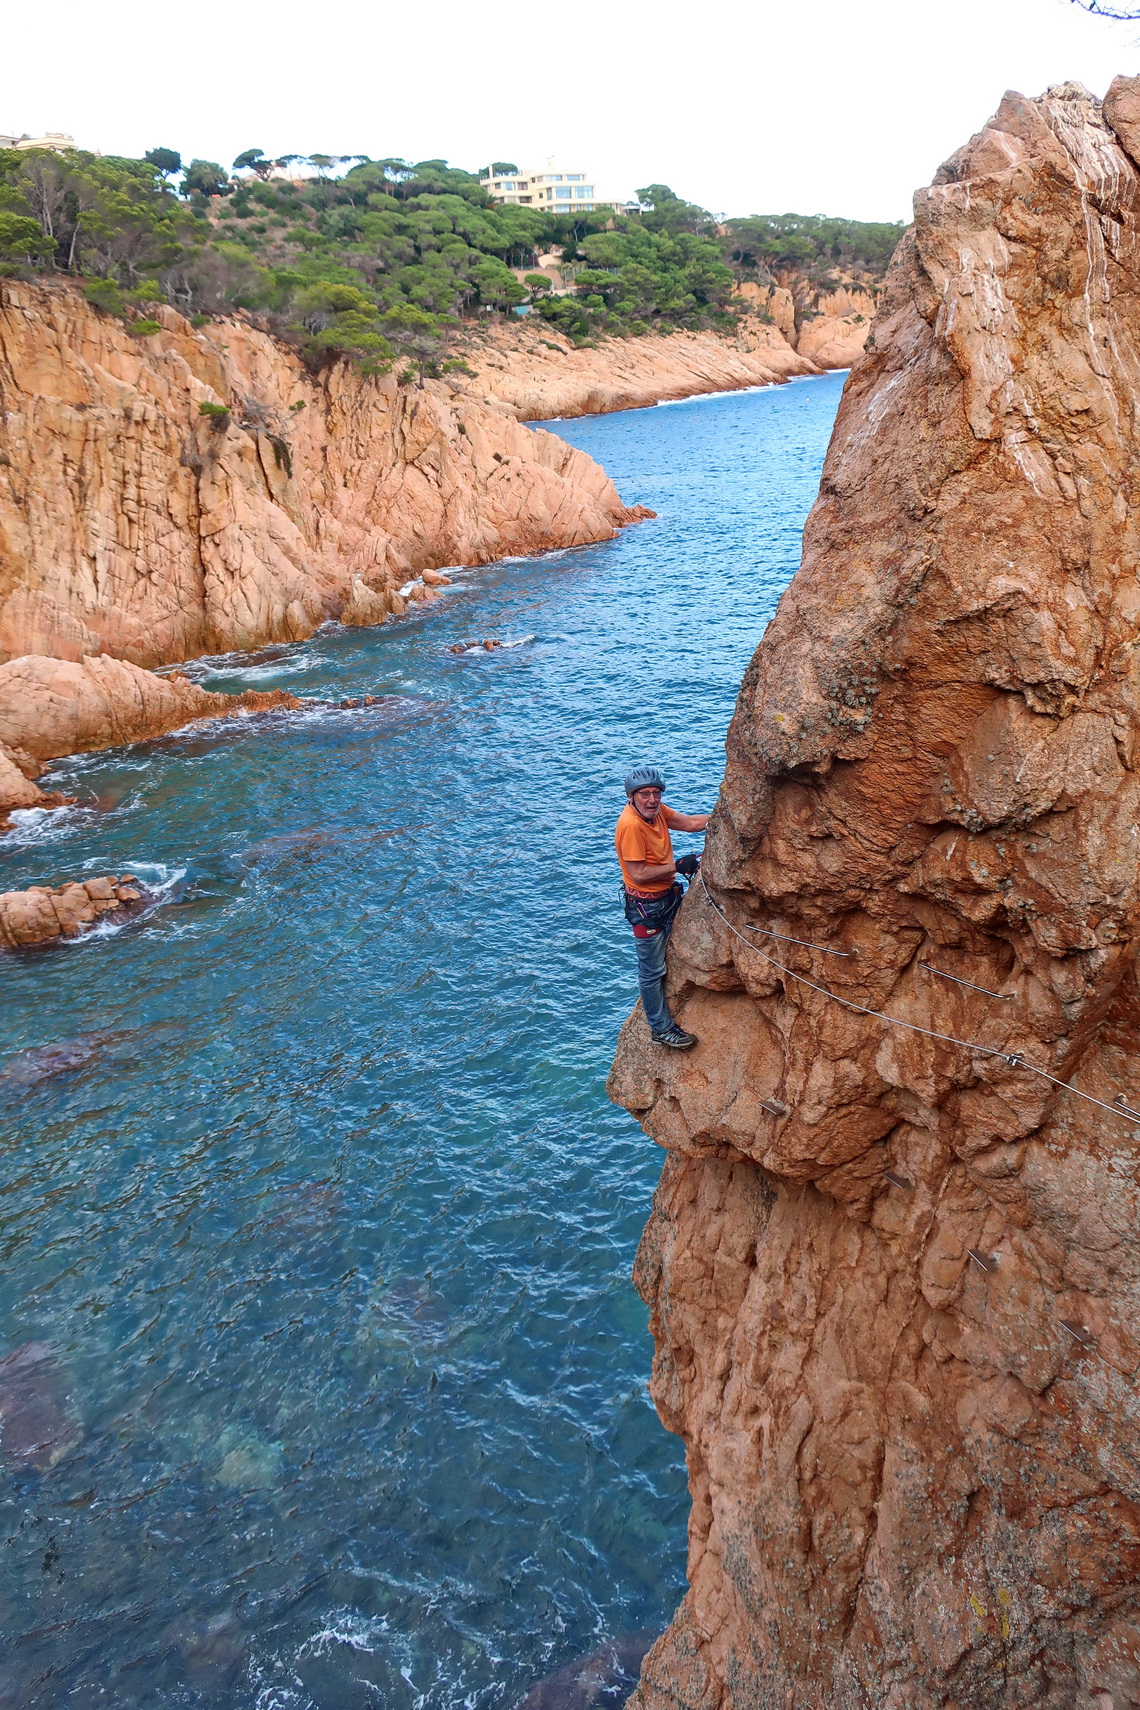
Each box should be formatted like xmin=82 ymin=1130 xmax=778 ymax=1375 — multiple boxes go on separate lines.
xmin=0 ymin=376 xmax=843 ymax=1710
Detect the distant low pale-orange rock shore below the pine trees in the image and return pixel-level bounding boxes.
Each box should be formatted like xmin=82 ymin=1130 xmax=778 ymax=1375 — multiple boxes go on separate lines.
xmin=447 ymin=321 xmax=820 ymax=421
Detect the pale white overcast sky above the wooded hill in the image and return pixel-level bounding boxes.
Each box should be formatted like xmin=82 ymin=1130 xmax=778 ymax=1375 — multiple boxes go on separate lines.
xmin=0 ymin=0 xmax=1140 ymax=219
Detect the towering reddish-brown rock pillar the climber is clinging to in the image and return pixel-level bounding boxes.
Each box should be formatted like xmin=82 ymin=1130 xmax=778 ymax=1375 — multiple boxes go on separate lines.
xmin=612 ymin=79 xmax=1140 ymax=1710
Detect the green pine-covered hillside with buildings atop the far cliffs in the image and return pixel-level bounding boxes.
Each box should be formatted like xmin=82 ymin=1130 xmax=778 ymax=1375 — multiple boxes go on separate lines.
xmin=0 ymin=149 xmax=902 ymax=383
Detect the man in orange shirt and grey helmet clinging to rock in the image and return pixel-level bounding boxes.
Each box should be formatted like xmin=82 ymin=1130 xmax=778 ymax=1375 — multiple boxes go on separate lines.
xmin=614 ymin=766 xmax=709 ymax=1052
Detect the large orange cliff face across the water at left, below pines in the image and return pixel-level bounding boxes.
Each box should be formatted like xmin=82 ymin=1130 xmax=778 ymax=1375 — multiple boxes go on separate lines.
xmin=0 ymin=280 xmax=644 ymax=665
